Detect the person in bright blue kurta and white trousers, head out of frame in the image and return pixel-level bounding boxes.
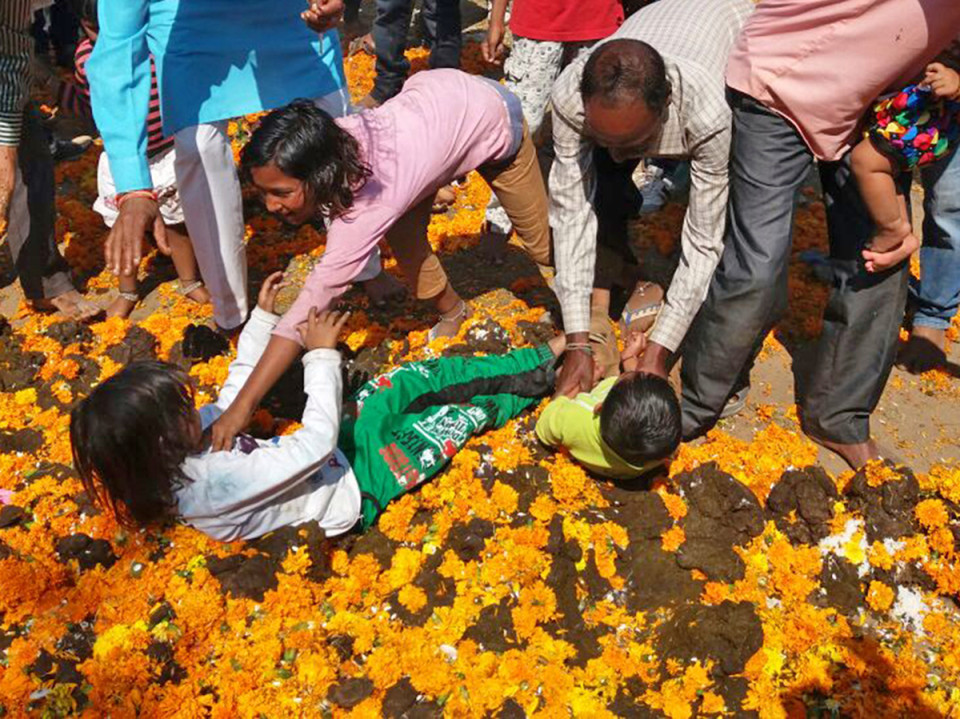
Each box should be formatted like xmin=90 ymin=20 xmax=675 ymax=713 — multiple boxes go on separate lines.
xmin=87 ymin=0 xmax=350 ymax=329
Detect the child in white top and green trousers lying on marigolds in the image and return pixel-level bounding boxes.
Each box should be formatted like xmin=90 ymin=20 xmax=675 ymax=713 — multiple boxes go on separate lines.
xmin=70 ymin=273 xmax=563 ymax=541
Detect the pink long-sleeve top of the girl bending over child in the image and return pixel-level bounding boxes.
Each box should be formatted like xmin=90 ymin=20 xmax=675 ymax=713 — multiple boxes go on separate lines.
xmin=274 ymin=70 xmax=515 ymax=342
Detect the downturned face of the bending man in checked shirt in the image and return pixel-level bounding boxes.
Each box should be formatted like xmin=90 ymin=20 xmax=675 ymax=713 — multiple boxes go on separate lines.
xmin=584 ymin=97 xmax=663 ymax=162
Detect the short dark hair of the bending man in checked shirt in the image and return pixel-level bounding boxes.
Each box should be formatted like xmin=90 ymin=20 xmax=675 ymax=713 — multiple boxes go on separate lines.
xmin=580 ymin=38 xmax=671 ymax=114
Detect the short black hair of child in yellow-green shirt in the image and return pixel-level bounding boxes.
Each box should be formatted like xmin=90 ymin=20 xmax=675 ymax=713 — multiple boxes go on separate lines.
xmin=600 ymin=372 xmax=681 ymax=465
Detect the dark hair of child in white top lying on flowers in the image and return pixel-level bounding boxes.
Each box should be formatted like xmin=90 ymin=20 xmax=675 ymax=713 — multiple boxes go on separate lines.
xmin=70 ymin=362 xmax=195 ymax=526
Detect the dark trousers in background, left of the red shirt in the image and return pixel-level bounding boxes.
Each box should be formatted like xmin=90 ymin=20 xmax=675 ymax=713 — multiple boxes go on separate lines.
xmin=370 ymin=0 xmax=462 ymax=103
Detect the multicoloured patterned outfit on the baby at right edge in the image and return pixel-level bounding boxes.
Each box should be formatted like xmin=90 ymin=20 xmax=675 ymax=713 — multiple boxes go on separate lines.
xmin=866 ymin=85 xmax=960 ymax=170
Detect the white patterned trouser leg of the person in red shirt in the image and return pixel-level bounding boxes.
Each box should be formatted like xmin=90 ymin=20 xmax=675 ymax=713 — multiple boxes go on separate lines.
xmin=486 ymin=36 xmax=564 ymax=235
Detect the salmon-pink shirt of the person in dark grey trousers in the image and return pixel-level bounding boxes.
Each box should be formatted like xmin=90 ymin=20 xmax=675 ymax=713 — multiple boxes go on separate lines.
xmin=727 ymin=0 xmax=960 ymax=160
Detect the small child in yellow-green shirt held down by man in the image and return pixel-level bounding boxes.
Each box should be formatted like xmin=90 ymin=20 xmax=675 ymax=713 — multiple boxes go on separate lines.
xmin=536 ymin=331 xmax=680 ymax=479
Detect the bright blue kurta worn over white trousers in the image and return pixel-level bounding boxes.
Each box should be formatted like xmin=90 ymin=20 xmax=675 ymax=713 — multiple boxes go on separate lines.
xmin=87 ymin=0 xmax=346 ymax=192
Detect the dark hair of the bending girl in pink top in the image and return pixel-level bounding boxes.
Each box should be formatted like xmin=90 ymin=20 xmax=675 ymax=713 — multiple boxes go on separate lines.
xmin=240 ymin=100 xmax=370 ymax=217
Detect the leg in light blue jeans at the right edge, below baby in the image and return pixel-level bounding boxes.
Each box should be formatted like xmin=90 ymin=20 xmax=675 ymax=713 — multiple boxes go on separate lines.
xmin=898 ymin=146 xmax=960 ymax=372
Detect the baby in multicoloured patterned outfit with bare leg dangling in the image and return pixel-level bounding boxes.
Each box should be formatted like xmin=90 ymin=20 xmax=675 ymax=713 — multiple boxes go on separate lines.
xmin=852 ymin=55 xmax=960 ymax=272
